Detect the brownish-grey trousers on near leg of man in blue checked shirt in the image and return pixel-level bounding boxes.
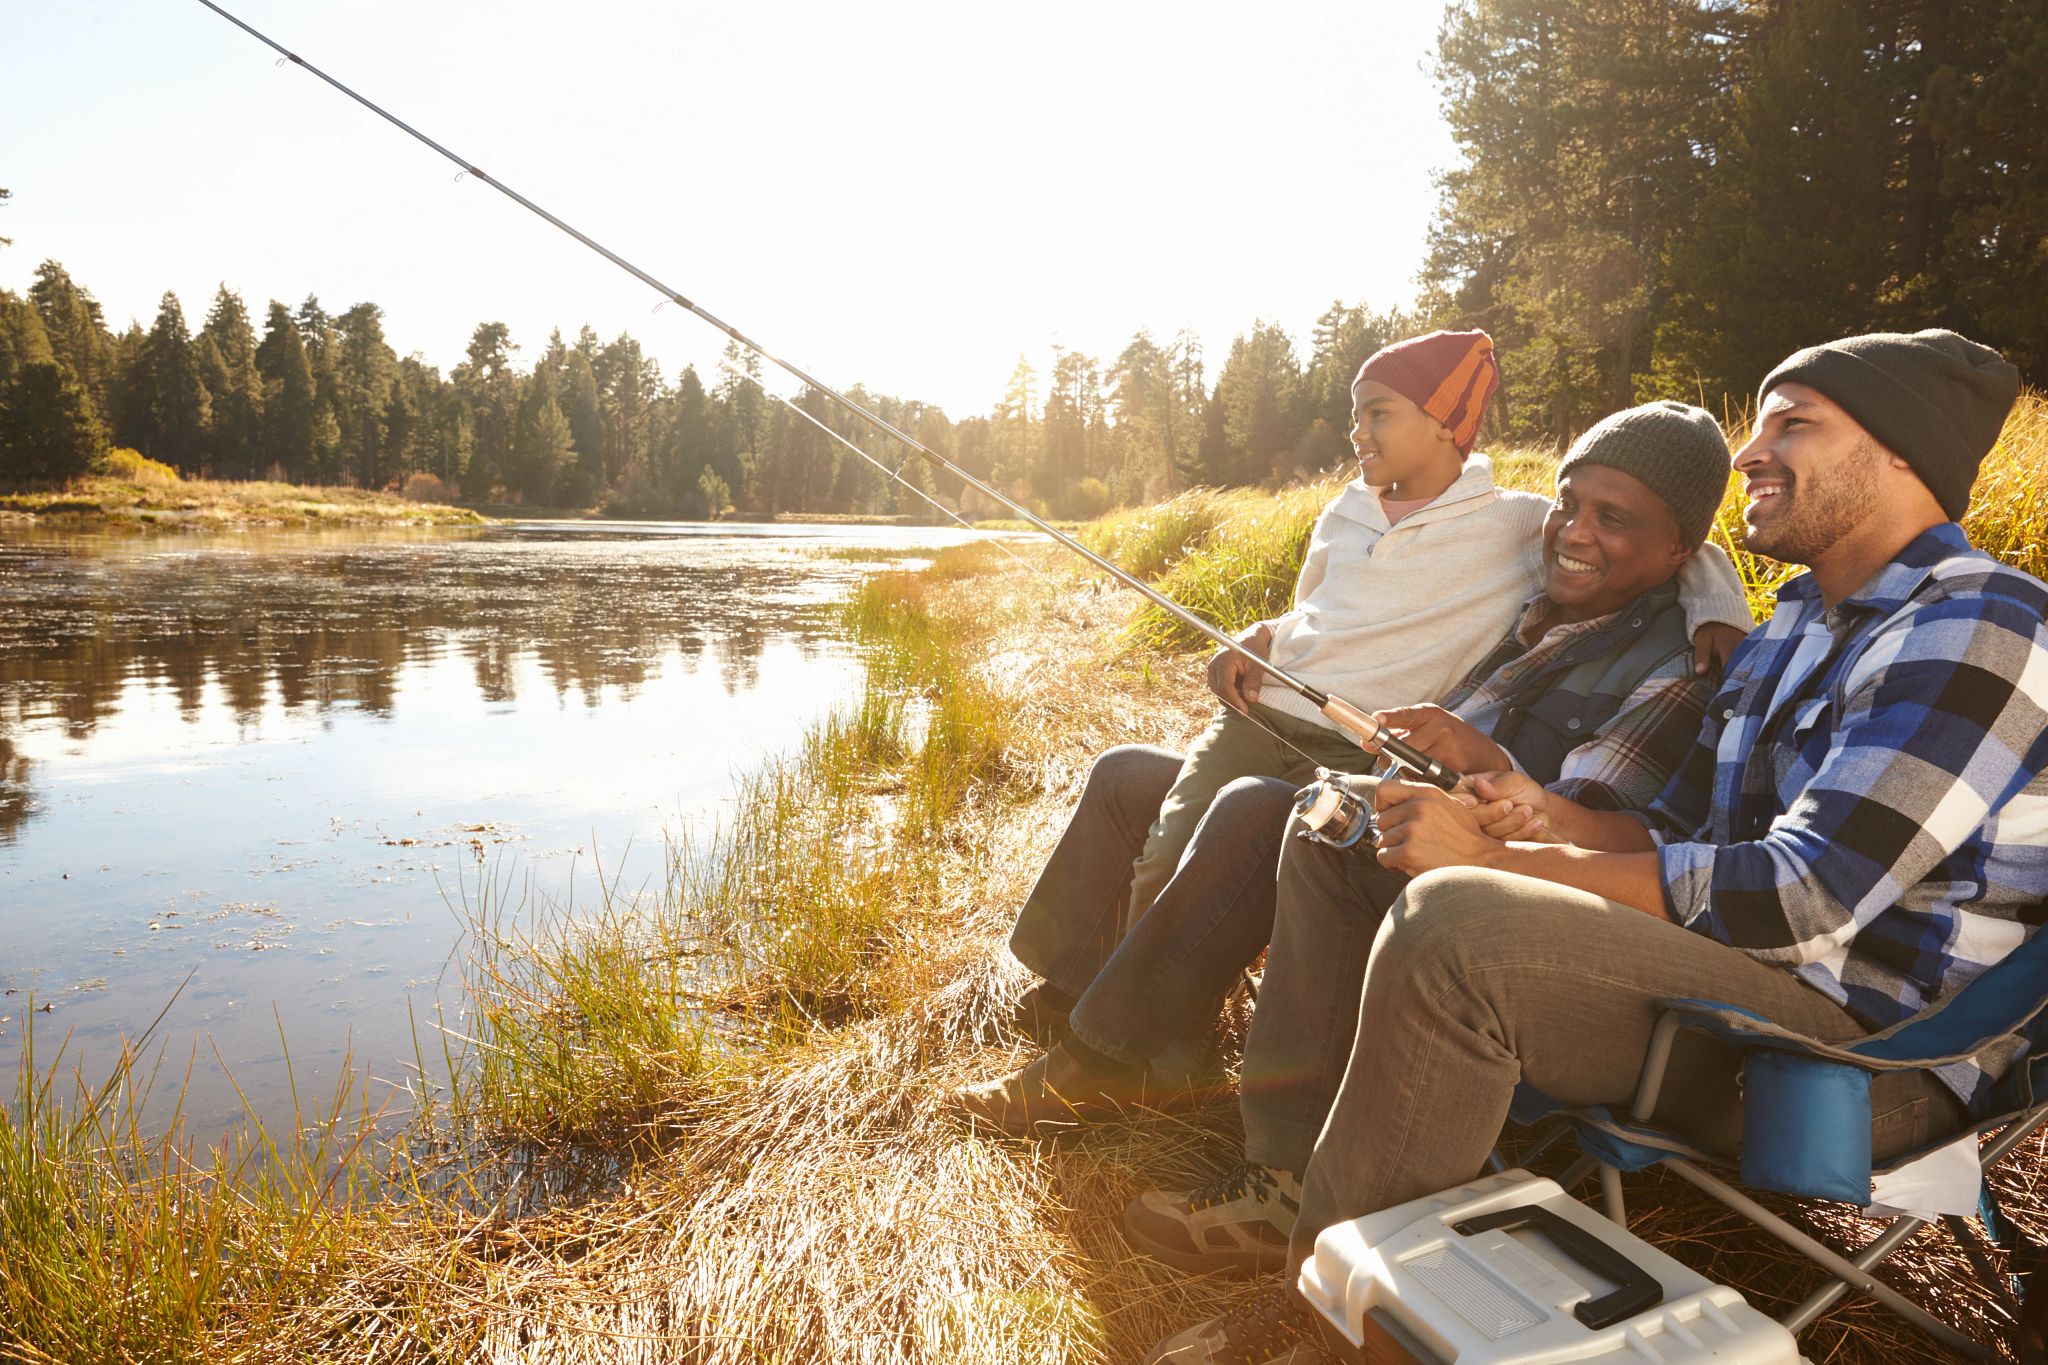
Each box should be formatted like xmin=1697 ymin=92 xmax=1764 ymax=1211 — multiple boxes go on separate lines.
xmin=1260 ymin=868 xmax=1962 ymax=1269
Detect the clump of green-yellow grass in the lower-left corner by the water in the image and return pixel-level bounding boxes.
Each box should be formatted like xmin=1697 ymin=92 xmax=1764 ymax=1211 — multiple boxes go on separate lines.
xmin=0 ymin=994 xmax=397 ymax=1361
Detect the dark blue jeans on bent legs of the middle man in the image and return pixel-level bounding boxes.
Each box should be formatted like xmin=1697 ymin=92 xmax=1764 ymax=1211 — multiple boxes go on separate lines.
xmin=1010 ymin=745 xmax=1296 ymax=1062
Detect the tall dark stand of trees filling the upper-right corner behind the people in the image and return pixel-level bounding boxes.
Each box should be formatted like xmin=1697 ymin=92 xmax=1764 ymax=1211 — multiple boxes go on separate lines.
xmin=1423 ymin=0 xmax=2048 ymax=438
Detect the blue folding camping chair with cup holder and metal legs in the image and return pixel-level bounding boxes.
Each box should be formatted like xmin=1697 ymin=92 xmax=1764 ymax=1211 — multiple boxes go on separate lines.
xmin=1495 ymin=933 xmax=2048 ymax=1361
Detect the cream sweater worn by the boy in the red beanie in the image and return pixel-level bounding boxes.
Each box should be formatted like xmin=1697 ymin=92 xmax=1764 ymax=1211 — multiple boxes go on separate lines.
xmin=1260 ymin=452 xmax=1753 ymax=729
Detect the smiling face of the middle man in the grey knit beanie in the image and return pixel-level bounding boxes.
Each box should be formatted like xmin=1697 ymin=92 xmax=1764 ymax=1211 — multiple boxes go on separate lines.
xmin=1542 ymin=465 xmax=1694 ymax=620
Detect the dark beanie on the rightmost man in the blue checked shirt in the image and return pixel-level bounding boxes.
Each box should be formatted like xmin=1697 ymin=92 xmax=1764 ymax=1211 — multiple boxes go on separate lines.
xmin=1757 ymin=327 xmax=2019 ymax=518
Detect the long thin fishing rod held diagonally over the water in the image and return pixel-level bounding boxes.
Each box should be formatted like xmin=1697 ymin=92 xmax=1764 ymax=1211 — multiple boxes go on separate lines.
xmin=199 ymin=0 xmax=1462 ymax=792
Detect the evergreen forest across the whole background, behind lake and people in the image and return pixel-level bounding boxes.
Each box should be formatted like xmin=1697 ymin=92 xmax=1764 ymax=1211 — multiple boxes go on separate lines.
xmin=0 ymin=0 xmax=2048 ymax=518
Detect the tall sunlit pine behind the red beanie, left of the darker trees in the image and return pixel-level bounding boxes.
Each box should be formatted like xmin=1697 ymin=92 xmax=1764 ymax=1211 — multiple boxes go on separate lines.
xmin=1425 ymin=0 xmax=1729 ymax=436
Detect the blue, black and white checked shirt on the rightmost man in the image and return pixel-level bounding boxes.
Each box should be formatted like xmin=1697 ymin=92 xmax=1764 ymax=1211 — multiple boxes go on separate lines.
xmin=1647 ymin=522 xmax=2048 ymax=1103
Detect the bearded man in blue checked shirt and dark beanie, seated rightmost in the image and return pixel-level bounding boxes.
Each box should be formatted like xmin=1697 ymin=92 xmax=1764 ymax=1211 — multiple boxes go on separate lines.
xmin=1151 ymin=332 xmax=2048 ymax=1363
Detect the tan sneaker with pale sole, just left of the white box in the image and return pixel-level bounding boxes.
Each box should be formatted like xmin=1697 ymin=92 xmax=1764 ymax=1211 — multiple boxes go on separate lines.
xmin=1124 ymin=1160 xmax=1300 ymax=1275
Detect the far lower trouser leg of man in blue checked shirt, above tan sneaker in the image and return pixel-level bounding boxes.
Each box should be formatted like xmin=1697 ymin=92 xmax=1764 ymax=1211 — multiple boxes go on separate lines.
xmin=1239 ymin=823 xmax=1407 ymax=1175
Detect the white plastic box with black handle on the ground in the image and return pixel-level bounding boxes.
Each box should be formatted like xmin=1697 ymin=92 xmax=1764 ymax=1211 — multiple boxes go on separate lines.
xmin=1300 ymin=1171 xmax=1800 ymax=1365
